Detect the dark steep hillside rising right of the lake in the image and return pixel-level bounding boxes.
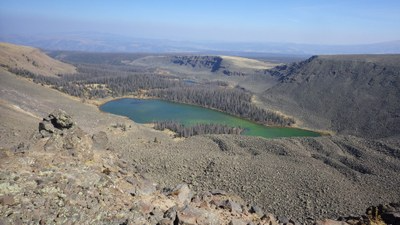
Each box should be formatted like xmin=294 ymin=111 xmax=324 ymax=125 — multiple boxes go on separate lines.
xmin=262 ymin=55 xmax=400 ymax=137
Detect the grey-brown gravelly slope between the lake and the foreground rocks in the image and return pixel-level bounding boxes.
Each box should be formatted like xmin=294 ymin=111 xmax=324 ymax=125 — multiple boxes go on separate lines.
xmin=108 ymin=131 xmax=400 ymax=221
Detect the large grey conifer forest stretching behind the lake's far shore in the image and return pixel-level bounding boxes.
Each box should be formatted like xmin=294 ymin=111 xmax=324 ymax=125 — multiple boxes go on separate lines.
xmin=9 ymin=64 xmax=294 ymax=126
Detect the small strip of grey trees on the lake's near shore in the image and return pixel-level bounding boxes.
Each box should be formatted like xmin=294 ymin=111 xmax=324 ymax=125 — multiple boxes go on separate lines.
xmin=154 ymin=121 xmax=244 ymax=137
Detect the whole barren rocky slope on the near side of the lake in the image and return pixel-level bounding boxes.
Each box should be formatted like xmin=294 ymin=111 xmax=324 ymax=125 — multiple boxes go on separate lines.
xmin=0 ymin=44 xmax=400 ymax=224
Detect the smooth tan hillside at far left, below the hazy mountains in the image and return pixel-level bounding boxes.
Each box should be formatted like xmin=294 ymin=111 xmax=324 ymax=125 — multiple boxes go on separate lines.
xmin=0 ymin=43 xmax=76 ymax=76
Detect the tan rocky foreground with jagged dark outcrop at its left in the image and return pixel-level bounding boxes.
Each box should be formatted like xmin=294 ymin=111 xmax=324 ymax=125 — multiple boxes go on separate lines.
xmin=0 ymin=110 xmax=400 ymax=225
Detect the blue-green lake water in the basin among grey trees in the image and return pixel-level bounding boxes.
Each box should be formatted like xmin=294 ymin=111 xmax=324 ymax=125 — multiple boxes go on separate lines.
xmin=100 ymin=98 xmax=320 ymax=138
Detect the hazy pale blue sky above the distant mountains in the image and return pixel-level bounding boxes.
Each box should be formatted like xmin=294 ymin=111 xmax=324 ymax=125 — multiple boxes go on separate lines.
xmin=0 ymin=0 xmax=400 ymax=44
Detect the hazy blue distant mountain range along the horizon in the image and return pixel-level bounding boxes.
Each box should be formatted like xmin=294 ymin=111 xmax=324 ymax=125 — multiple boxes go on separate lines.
xmin=0 ymin=32 xmax=400 ymax=56
